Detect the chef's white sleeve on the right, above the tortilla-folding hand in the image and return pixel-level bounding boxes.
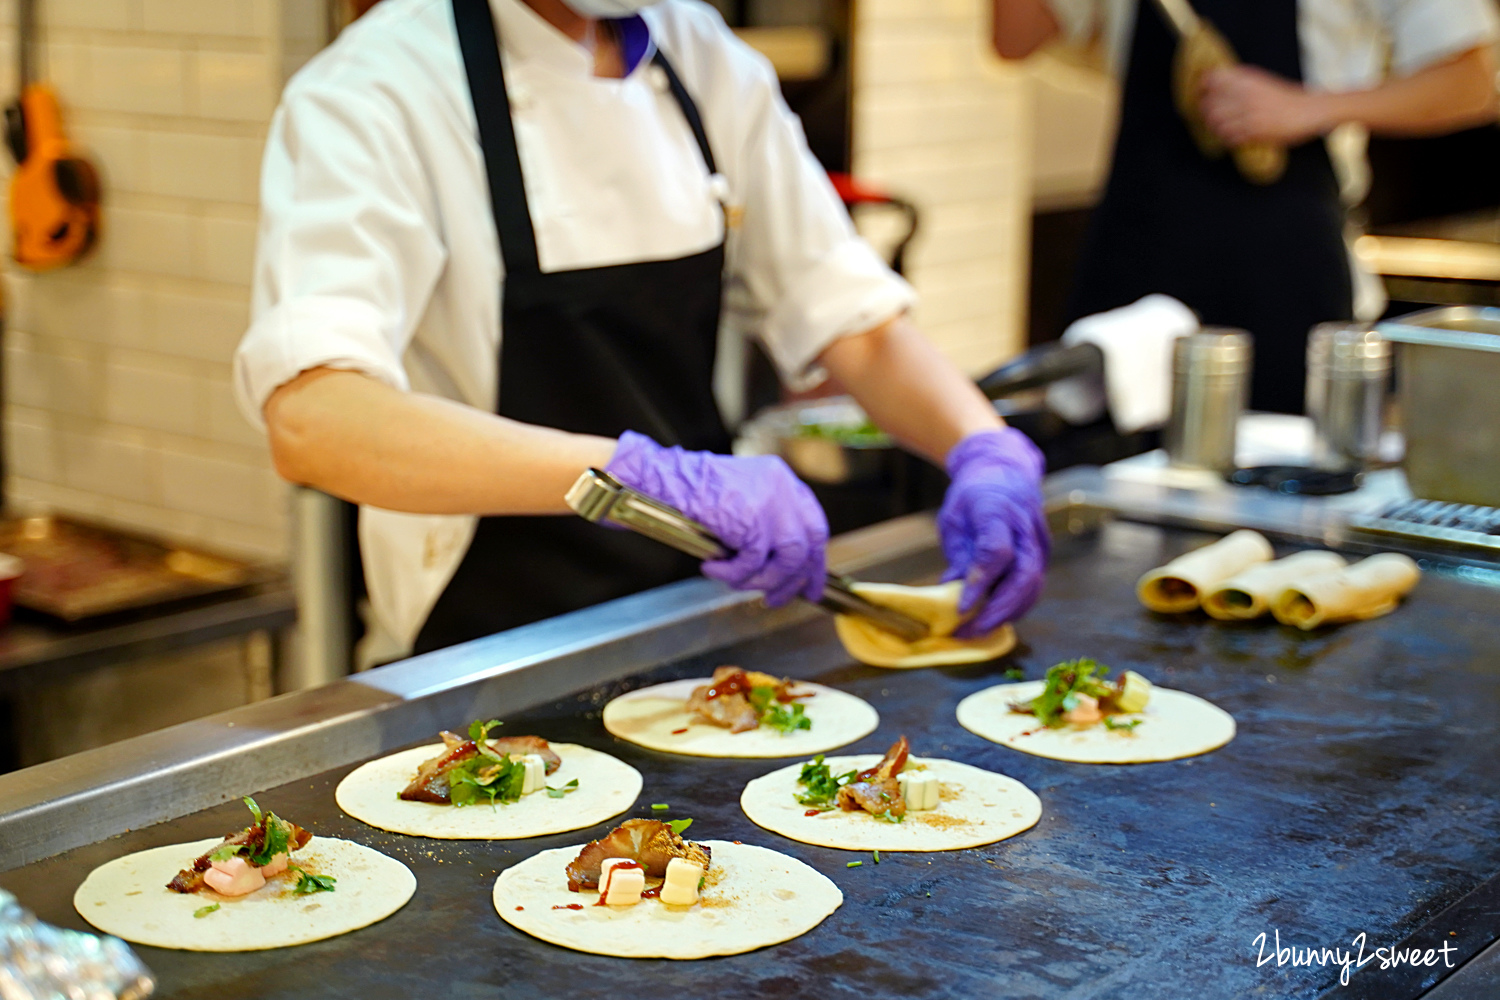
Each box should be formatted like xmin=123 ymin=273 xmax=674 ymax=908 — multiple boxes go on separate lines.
xmin=716 ymin=22 xmax=917 ymax=385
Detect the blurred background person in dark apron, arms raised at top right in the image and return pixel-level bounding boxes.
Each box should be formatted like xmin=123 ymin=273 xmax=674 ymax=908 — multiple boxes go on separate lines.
xmin=993 ymin=0 xmax=1500 ymax=414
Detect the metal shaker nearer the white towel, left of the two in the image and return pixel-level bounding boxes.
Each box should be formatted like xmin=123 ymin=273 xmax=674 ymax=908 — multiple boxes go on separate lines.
xmin=1164 ymin=327 xmax=1254 ymax=472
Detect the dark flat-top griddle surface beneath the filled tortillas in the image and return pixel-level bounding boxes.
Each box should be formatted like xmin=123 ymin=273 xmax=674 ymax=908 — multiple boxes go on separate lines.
xmin=0 ymin=525 xmax=1500 ymax=1000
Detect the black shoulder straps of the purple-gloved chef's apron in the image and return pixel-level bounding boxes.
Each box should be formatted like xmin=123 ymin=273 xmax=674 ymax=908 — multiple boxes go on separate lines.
xmin=453 ymin=0 xmax=719 ymax=274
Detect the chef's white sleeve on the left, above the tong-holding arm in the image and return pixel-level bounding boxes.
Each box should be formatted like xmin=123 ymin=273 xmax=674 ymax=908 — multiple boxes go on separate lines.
xmin=234 ymin=81 xmax=447 ymax=427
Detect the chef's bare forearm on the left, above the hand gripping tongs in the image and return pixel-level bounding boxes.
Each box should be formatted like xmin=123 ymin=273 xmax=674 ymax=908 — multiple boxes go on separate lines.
xmin=264 ymin=369 xmax=615 ymax=514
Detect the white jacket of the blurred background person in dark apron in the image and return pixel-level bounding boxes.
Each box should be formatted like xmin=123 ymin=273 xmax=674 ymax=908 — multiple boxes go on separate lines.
xmin=1047 ymin=0 xmax=1500 ymax=319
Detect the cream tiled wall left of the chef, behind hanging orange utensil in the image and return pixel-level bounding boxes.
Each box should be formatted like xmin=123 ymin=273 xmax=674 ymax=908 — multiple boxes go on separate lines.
xmin=0 ymin=0 xmax=289 ymax=559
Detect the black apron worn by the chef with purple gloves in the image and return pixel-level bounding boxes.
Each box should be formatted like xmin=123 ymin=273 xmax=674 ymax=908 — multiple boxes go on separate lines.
xmin=416 ymin=0 xmax=731 ymax=652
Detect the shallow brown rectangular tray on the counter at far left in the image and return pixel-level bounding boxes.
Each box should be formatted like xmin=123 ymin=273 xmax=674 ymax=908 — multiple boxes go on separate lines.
xmin=0 ymin=517 xmax=260 ymax=622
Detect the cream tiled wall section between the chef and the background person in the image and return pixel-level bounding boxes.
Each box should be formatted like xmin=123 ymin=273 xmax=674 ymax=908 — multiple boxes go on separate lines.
xmin=854 ymin=0 xmax=1032 ymax=375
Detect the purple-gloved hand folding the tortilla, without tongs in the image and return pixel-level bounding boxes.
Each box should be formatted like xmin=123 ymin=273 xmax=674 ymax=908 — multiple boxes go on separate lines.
xmin=938 ymin=427 xmax=1052 ymax=639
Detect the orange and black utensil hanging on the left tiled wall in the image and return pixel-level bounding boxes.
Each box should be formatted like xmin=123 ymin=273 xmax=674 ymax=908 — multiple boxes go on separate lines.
xmin=5 ymin=0 xmax=101 ymax=271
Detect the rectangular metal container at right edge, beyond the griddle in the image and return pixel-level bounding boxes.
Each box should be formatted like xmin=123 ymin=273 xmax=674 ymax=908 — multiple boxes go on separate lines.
xmin=1380 ymin=306 xmax=1500 ymax=507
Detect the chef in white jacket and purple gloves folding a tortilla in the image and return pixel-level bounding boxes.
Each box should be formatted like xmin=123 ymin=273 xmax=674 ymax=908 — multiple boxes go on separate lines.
xmin=236 ymin=0 xmax=1047 ymax=652
